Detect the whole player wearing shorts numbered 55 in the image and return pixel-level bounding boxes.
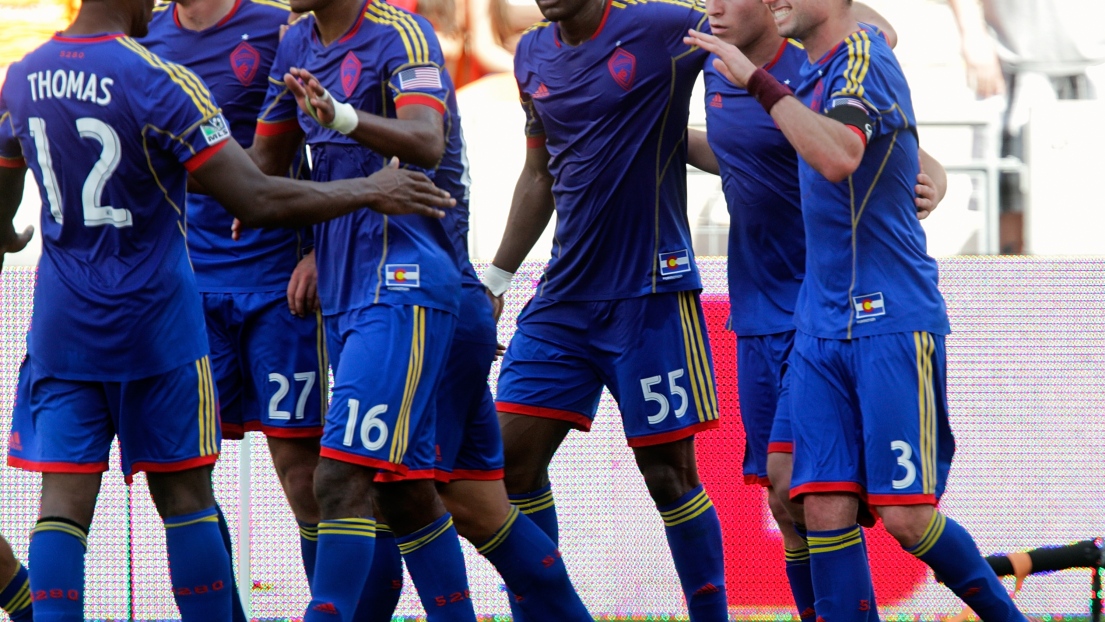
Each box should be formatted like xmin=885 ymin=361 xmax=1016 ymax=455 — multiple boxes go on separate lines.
xmin=484 ymin=0 xmax=728 ymax=622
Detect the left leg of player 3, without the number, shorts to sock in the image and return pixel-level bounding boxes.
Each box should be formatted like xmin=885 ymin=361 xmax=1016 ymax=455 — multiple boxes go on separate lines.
xmin=780 ymin=333 xmax=874 ymax=622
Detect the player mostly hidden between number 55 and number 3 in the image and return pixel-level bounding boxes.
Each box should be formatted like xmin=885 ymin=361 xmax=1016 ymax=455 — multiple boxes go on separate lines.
xmin=687 ymin=0 xmax=946 ymax=619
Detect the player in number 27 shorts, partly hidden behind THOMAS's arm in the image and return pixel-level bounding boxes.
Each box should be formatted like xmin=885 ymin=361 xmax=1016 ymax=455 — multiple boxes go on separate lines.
xmin=141 ymin=0 xmax=329 ymax=592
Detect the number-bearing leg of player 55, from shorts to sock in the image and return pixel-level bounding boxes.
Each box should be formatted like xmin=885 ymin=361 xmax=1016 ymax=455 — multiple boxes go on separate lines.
xmin=605 ymin=292 xmax=728 ymax=622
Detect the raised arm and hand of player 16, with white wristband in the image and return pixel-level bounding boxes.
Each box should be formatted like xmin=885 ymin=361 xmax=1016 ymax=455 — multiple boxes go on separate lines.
xmin=284 ymin=67 xmax=445 ymax=168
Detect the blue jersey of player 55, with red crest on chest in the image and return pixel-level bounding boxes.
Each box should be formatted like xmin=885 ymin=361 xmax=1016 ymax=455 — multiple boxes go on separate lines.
xmin=514 ymin=0 xmax=707 ymax=301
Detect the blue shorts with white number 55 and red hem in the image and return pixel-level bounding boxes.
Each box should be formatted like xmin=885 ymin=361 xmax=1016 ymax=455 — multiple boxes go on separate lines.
xmin=496 ymin=292 xmax=718 ymax=447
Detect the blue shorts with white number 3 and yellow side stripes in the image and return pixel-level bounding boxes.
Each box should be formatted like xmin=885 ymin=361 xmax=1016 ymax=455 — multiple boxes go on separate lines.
xmin=789 ymin=333 xmax=955 ymax=507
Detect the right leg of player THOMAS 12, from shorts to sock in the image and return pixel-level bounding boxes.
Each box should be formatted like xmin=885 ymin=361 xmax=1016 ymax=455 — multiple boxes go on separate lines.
xmin=119 ymin=357 xmax=234 ymax=622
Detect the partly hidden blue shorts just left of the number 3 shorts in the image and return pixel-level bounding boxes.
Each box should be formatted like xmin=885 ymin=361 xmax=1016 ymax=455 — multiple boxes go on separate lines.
xmin=737 ymin=330 xmax=794 ymax=486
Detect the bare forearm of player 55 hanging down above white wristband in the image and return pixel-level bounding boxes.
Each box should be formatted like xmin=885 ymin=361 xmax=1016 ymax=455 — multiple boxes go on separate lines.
xmin=492 ymin=171 xmax=554 ymax=272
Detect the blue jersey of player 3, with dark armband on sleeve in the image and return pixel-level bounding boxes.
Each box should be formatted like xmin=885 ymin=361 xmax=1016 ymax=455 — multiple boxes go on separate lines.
xmin=794 ymin=25 xmax=949 ymax=339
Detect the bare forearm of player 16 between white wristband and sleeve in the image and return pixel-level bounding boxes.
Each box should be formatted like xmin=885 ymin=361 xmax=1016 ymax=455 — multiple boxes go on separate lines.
xmin=349 ymin=110 xmax=445 ymax=168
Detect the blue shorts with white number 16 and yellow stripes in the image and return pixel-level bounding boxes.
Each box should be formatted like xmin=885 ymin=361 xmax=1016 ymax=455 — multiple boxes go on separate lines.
xmin=320 ymin=305 xmax=456 ymax=478
